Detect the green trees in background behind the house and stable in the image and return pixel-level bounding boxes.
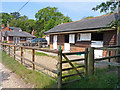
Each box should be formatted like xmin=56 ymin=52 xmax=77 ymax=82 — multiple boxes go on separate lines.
xmin=0 ymin=7 xmax=72 ymax=37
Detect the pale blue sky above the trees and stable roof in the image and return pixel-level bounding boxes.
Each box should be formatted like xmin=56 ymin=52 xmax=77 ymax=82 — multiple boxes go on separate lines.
xmin=1 ymin=0 xmax=108 ymax=21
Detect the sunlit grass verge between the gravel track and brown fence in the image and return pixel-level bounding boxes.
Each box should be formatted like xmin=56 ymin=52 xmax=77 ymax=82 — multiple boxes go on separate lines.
xmin=2 ymin=53 xmax=56 ymax=88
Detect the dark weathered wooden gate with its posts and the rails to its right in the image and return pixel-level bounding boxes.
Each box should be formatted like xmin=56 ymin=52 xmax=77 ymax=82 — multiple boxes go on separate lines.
xmin=58 ymin=46 xmax=120 ymax=88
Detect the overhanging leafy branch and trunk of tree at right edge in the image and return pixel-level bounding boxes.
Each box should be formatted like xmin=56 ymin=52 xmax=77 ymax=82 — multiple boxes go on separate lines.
xmin=92 ymin=0 xmax=120 ymax=63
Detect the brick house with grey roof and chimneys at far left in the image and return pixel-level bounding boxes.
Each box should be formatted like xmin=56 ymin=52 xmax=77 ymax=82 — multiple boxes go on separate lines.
xmin=0 ymin=24 xmax=36 ymax=44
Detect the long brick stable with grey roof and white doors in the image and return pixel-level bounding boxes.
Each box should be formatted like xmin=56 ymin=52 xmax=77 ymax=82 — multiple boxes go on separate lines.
xmin=45 ymin=13 xmax=118 ymax=57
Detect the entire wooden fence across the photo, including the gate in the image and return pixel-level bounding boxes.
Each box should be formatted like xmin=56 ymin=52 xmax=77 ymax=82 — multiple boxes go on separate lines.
xmin=1 ymin=43 xmax=120 ymax=88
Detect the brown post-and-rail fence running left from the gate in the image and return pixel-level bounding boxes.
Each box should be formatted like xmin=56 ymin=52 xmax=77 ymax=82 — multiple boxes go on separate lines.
xmin=1 ymin=44 xmax=58 ymax=74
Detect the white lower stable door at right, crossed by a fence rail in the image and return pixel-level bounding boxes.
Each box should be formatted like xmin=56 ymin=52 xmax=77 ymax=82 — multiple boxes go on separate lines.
xmin=91 ymin=41 xmax=103 ymax=58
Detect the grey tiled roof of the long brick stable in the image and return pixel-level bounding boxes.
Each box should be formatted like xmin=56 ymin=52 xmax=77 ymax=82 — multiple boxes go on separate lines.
xmin=45 ymin=13 xmax=118 ymax=34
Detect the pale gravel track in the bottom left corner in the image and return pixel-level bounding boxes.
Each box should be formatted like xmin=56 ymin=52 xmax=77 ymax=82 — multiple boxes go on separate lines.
xmin=0 ymin=63 xmax=33 ymax=89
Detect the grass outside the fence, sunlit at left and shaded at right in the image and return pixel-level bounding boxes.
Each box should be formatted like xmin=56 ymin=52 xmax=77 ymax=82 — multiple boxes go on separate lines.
xmin=2 ymin=53 xmax=120 ymax=88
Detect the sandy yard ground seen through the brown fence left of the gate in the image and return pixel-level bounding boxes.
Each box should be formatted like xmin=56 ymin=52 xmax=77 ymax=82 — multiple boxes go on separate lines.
xmin=16 ymin=51 xmax=58 ymax=77
